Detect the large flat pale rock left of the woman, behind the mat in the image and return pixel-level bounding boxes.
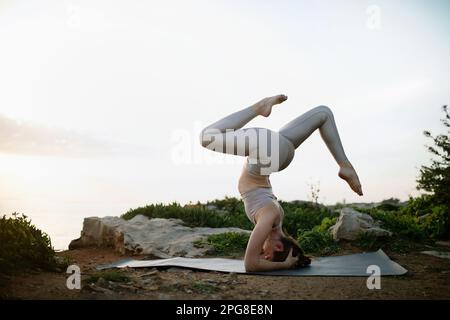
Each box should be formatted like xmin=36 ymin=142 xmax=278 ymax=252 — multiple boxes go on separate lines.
xmin=69 ymin=215 xmax=250 ymax=258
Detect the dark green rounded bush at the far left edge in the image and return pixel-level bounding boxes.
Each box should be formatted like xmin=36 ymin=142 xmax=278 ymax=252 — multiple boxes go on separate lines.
xmin=0 ymin=213 xmax=57 ymax=274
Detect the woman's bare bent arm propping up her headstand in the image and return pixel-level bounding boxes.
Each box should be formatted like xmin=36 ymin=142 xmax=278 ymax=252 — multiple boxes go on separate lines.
xmin=244 ymin=206 xmax=297 ymax=272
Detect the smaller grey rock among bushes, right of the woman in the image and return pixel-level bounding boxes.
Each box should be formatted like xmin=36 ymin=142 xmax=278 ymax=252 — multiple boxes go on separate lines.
xmin=330 ymin=207 xmax=392 ymax=240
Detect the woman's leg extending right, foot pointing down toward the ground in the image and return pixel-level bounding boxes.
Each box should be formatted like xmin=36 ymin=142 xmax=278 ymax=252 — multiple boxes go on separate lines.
xmin=279 ymin=106 xmax=362 ymax=195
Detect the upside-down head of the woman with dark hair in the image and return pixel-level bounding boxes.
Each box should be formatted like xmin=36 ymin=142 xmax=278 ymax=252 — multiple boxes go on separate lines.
xmin=263 ymin=232 xmax=311 ymax=266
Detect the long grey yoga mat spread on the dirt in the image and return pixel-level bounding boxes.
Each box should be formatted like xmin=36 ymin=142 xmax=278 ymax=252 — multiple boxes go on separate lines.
xmin=97 ymin=249 xmax=408 ymax=277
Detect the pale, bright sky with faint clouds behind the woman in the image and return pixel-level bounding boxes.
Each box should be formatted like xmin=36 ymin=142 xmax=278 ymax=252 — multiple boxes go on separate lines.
xmin=0 ymin=0 xmax=450 ymax=248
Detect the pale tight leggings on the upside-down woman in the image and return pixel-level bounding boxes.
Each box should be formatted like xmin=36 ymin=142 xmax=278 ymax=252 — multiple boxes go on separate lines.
xmin=200 ymin=106 xmax=348 ymax=176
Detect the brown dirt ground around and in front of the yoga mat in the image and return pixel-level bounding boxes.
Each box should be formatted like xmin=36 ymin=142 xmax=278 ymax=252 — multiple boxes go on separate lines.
xmin=0 ymin=248 xmax=450 ymax=300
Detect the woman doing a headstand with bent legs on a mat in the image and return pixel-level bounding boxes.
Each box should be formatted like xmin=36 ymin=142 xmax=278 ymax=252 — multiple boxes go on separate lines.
xmin=200 ymin=95 xmax=363 ymax=272
